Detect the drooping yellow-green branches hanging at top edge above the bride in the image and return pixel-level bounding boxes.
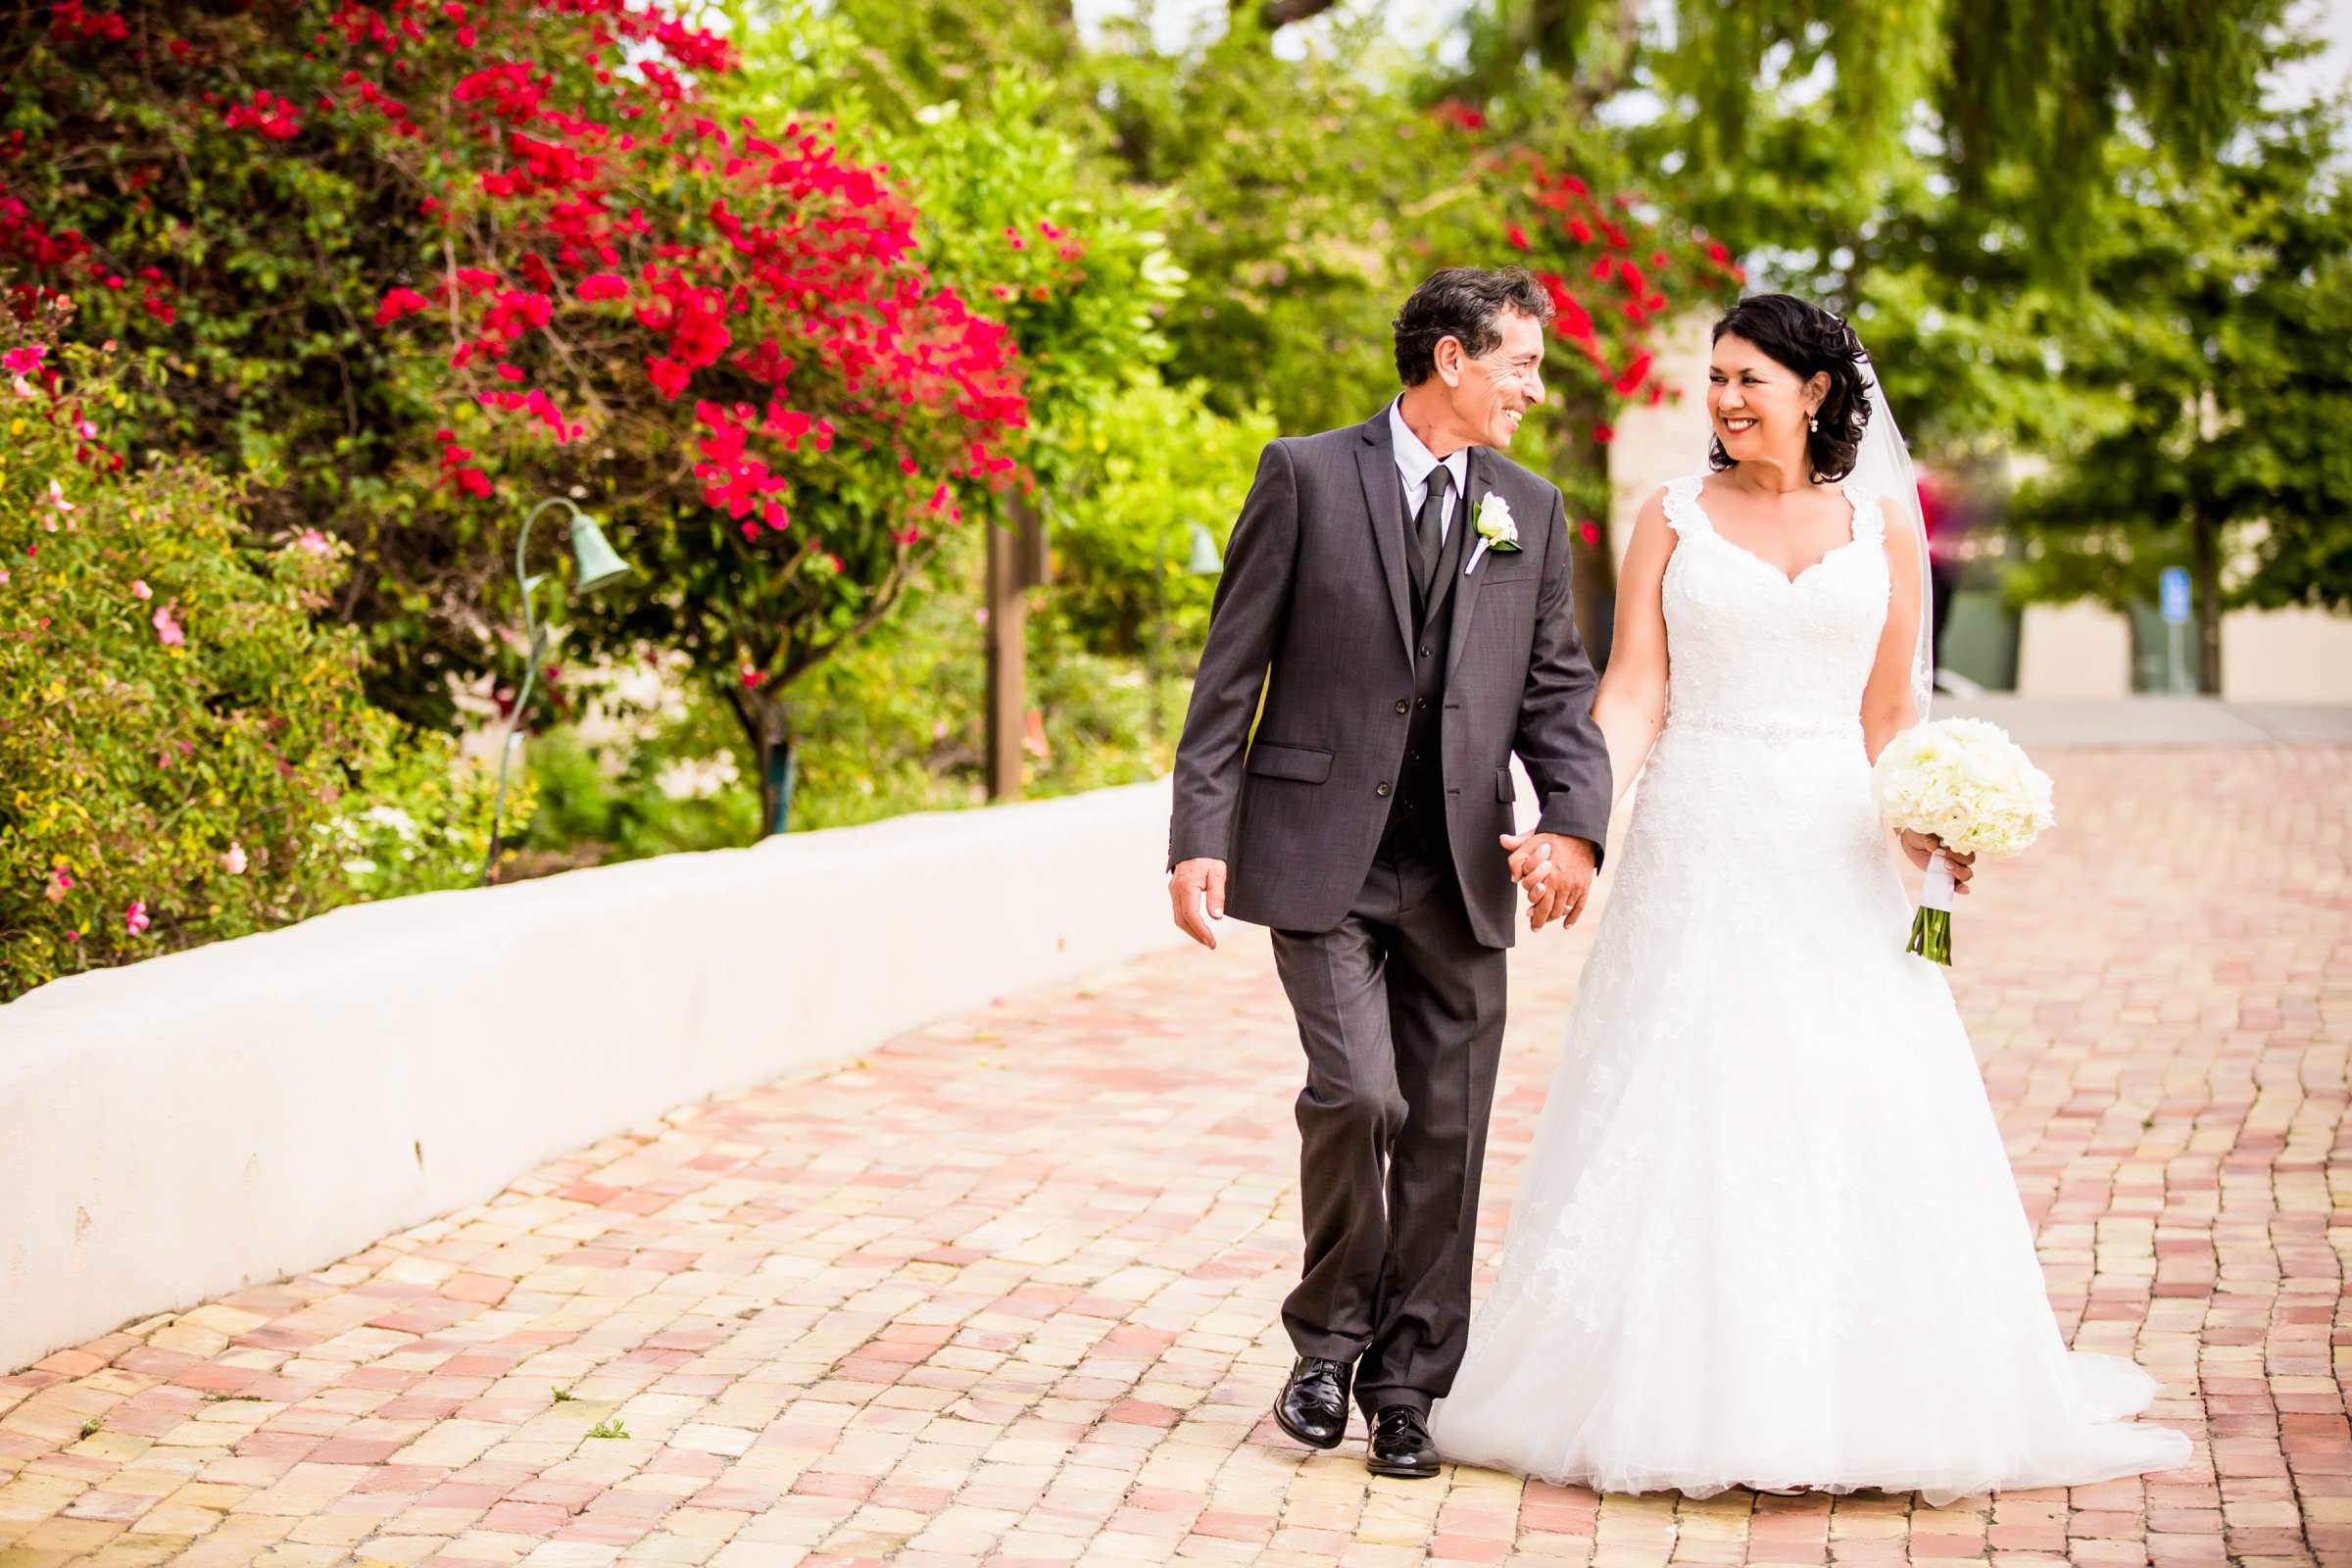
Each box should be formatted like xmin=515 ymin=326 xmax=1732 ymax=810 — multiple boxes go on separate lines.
xmin=1608 ymin=0 xmax=2286 ymax=266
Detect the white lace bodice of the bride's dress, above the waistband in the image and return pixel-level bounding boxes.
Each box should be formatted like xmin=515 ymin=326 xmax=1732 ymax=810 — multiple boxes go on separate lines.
xmin=1663 ymin=475 xmax=1888 ymax=733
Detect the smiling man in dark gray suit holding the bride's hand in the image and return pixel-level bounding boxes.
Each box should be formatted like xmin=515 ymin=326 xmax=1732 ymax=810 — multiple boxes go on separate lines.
xmin=1169 ymin=268 xmax=1609 ymax=1476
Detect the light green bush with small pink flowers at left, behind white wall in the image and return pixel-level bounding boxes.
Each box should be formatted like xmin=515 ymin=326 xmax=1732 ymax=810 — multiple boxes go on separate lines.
xmin=0 ymin=328 xmax=529 ymax=997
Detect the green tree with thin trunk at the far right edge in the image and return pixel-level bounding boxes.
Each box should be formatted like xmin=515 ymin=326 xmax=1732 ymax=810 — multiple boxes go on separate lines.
xmin=2018 ymin=104 xmax=2352 ymax=694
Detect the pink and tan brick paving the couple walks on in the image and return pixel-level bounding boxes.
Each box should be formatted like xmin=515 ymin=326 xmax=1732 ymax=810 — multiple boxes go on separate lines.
xmin=0 ymin=750 xmax=2352 ymax=1568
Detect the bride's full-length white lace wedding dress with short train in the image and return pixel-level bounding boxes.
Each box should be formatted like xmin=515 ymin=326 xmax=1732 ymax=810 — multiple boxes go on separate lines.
xmin=1433 ymin=477 xmax=2189 ymax=1504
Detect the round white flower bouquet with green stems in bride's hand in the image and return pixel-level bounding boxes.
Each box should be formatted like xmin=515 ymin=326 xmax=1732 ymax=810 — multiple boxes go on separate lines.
xmin=1870 ymin=719 xmax=2056 ymax=964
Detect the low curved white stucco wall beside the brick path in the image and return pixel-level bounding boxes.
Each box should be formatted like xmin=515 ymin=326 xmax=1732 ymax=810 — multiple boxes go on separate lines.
xmin=0 ymin=783 xmax=1183 ymax=1371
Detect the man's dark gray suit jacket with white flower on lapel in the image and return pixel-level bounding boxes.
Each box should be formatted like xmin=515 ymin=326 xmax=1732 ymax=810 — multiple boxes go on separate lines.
xmin=1169 ymin=407 xmax=1609 ymax=948
